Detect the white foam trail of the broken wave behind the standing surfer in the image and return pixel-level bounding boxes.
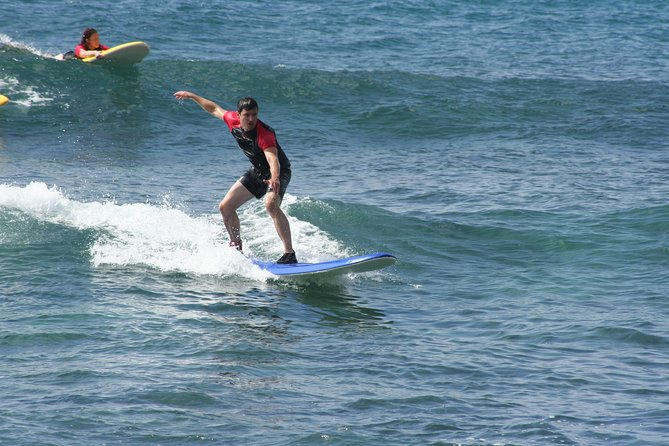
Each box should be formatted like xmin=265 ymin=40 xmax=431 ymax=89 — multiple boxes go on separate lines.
xmin=0 ymin=182 xmax=347 ymax=280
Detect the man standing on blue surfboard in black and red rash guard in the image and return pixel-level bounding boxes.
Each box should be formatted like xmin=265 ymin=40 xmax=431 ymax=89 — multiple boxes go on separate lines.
xmin=174 ymin=91 xmax=297 ymax=263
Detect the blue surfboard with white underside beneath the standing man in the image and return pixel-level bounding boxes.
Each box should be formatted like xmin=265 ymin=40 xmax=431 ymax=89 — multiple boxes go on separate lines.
xmin=252 ymin=252 xmax=397 ymax=277
